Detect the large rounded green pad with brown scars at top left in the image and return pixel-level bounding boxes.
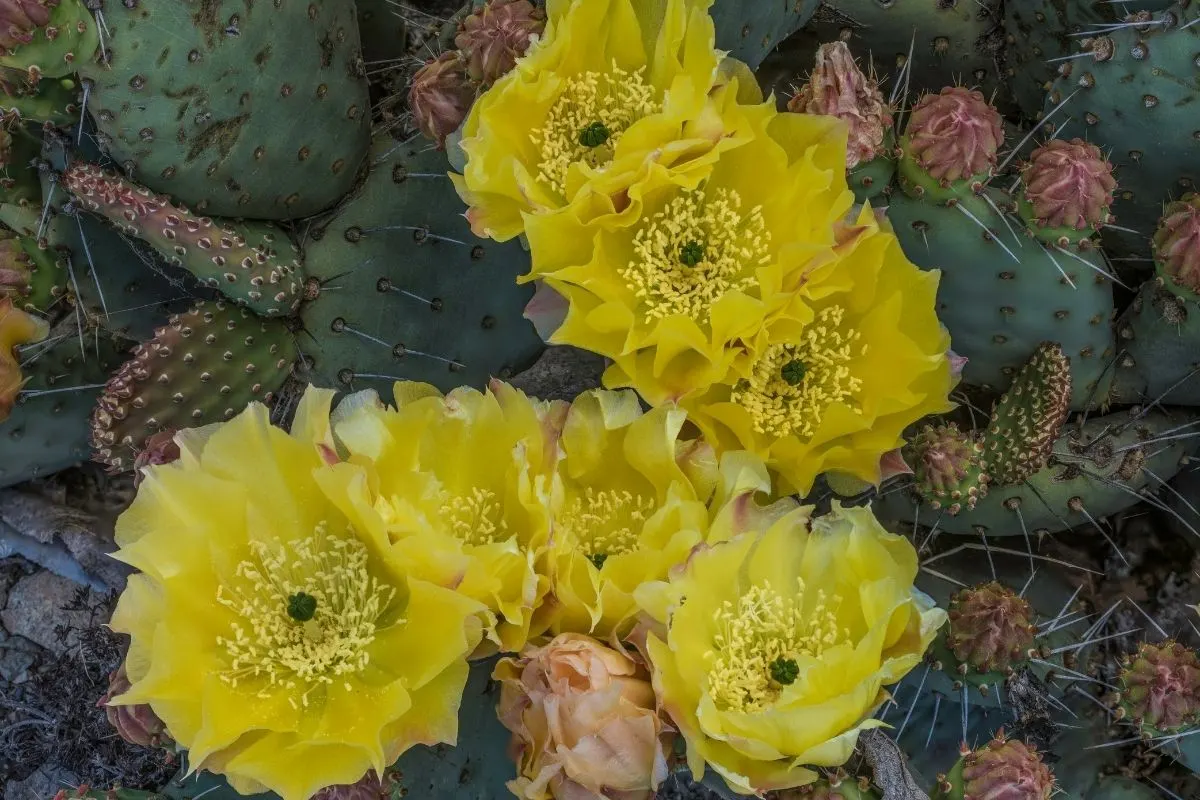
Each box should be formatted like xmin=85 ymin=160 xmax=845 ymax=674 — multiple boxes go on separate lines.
xmin=80 ymin=0 xmax=370 ymax=219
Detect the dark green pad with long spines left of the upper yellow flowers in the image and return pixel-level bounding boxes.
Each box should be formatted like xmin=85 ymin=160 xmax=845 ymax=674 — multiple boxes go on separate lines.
xmin=300 ymin=139 xmax=544 ymax=395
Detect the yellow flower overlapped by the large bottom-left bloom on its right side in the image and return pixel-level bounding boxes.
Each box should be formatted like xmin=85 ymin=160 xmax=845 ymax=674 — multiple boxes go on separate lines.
xmin=319 ymin=381 xmax=566 ymax=655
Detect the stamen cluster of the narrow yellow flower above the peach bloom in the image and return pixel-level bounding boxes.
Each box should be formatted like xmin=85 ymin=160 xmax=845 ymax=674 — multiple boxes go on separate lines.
xmin=554 ymin=487 xmax=654 ymax=569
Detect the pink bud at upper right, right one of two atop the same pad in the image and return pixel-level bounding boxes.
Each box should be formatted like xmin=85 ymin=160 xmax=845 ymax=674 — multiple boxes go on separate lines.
xmin=1018 ymin=139 xmax=1117 ymax=247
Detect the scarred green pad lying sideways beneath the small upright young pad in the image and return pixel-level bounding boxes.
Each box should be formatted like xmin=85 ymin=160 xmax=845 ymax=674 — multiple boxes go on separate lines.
xmin=875 ymin=409 xmax=1200 ymax=537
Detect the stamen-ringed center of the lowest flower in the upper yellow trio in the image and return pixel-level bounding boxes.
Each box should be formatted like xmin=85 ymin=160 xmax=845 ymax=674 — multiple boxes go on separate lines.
xmin=730 ymin=306 xmax=866 ymax=439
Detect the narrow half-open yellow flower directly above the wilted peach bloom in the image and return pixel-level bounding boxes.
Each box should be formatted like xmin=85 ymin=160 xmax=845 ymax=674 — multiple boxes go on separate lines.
xmin=539 ymin=391 xmax=716 ymax=638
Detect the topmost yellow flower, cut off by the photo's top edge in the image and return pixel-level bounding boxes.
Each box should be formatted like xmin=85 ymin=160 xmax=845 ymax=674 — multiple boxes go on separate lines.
xmin=450 ymin=0 xmax=748 ymax=241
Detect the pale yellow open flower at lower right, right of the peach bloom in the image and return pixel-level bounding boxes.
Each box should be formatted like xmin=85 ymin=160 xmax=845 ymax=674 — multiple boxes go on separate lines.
xmin=637 ymin=503 xmax=946 ymax=795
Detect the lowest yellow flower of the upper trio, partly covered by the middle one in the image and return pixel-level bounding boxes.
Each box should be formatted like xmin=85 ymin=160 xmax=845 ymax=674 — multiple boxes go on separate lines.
xmin=680 ymin=207 xmax=955 ymax=494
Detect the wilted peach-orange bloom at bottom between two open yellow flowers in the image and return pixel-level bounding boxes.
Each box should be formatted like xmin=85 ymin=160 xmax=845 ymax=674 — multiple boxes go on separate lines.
xmin=494 ymin=633 xmax=668 ymax=800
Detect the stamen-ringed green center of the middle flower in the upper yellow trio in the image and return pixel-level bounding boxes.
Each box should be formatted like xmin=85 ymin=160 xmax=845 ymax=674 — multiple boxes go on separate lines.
xmin=620 ymin=188 xmax=770 ymax=324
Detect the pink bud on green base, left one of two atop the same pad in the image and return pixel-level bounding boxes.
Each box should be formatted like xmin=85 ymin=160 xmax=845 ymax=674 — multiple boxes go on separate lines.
xmin=899 ymin=86 xmax=1004 ymax=201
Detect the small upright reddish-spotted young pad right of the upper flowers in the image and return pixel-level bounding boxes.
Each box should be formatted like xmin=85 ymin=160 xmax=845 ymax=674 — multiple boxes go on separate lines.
xmin=983 ymin=342 xmax=1070 ymax=486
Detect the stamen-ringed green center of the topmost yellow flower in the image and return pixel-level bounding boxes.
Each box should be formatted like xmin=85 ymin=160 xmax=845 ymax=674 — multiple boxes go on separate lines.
xmin=529 ymin=62 xmax=662 ymax=194
